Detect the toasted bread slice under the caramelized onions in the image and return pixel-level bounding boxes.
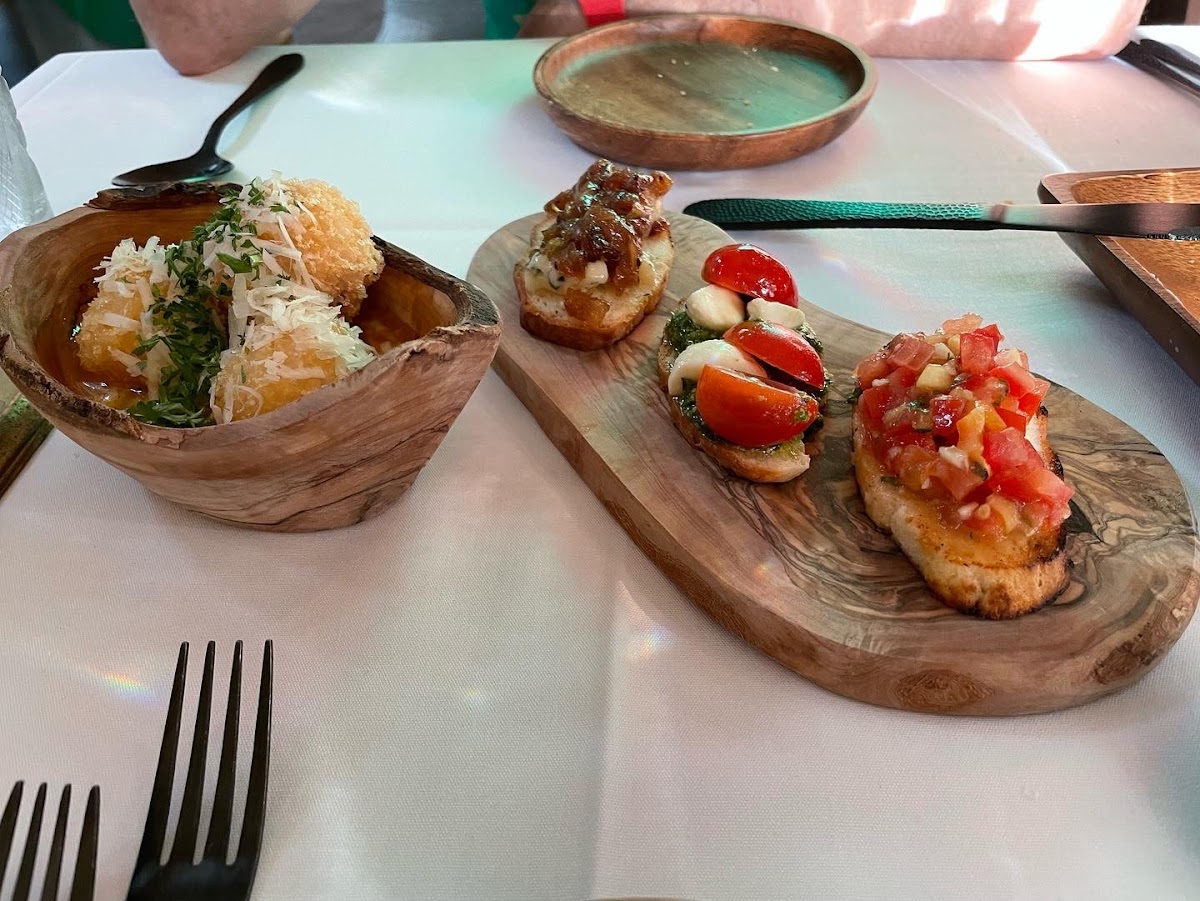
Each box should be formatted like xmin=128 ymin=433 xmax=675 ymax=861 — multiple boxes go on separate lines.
xmin=512 ymin=228 xmax=674 ymax=350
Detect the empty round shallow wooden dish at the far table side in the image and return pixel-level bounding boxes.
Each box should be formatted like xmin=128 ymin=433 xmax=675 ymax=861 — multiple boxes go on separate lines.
xmin=533 ymin=14 xmax=876 ymax=169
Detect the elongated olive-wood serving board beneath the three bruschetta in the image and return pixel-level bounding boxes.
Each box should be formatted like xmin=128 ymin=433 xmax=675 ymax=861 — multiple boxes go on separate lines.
xmin=468 ymin=215 xmax=1200 ymax=714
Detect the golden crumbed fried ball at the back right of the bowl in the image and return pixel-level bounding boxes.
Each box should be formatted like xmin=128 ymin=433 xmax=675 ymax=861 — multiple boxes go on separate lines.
xmin=259 ymin=179 xmax=383 ymax=320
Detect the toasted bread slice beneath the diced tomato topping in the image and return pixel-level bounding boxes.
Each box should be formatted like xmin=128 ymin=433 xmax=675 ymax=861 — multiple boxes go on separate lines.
xmin=853 ymin=407 xmax=1069 ymax=619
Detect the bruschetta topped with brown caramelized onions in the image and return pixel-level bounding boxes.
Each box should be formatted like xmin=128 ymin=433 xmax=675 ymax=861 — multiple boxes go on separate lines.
xmin=514 ymin=160 xmax=674 ymax=350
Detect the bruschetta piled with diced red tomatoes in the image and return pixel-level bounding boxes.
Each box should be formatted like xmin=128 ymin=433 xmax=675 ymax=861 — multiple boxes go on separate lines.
xmin=853 ymin=314 xmax=1073 ymax=619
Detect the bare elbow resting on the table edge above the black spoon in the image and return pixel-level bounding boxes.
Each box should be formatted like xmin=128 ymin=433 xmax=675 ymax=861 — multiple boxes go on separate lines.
xmin=130 ymin=0 xmax=317 ymax=76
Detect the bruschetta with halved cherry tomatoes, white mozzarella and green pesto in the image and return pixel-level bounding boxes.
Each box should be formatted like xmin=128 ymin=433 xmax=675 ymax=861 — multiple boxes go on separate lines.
xmin=658 ymin=239 xmax=828 ymax=482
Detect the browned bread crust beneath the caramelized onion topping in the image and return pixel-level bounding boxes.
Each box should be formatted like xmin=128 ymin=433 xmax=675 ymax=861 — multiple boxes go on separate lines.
xmin=512 ymin=229 xmax=674 ymax=350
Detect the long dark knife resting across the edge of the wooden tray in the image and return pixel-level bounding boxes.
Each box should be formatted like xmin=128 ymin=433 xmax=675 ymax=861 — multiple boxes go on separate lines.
xmin=683 ymin=197 xmax=1200 ymax=241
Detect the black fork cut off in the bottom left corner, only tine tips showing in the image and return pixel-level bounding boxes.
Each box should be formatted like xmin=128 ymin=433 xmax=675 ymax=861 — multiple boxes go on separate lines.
xmin=0 ymin=782 xmax=100 ymax=901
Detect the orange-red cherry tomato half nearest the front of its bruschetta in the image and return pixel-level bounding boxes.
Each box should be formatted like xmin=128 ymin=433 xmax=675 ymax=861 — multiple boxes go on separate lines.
xmin=696 ymin=366 xmax=818 ymax=448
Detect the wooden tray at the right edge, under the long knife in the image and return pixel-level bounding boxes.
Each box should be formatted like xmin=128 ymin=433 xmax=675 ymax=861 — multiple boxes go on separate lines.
xmin=1039 ymin=169 xmax=1200 ymax=383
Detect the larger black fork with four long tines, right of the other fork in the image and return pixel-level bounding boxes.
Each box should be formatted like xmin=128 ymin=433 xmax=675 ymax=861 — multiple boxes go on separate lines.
xmin=127 ymin=642 xmax=272 ymax=901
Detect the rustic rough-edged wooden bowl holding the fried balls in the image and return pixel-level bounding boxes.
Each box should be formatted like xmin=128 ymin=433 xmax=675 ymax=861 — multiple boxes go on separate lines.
xmin=0 ymin=186 xmax=500 ymax=531
